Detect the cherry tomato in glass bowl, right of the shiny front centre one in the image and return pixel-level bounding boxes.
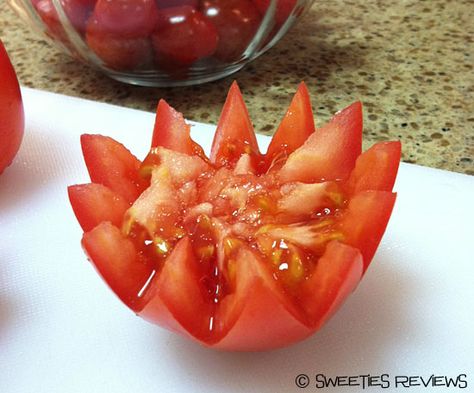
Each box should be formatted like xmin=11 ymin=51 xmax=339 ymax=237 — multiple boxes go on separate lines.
xmin=201 ymin=0 xmax=261 ymax=62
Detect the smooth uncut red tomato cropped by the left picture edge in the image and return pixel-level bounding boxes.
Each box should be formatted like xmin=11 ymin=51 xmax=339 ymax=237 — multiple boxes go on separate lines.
xmin=0 ymin=41 xmax=25 ymax=174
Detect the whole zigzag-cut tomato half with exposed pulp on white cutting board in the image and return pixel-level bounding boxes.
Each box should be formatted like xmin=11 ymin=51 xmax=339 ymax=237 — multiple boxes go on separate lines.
xmin=69 ymin=83 xmax=400 ymax=350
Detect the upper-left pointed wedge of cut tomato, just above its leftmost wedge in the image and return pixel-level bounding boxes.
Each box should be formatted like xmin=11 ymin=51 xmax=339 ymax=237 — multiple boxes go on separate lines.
xmin=81 ymin=134 xmax=146 ymax=203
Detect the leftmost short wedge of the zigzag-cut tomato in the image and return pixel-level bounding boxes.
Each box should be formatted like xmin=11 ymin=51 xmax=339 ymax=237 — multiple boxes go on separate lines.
xmin=67 ymin=183 xmax=130 ymax=232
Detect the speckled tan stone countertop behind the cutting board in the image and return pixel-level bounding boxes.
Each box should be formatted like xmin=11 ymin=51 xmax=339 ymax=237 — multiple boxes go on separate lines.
xmin=0 ymin=0 xmax=474 ymax=175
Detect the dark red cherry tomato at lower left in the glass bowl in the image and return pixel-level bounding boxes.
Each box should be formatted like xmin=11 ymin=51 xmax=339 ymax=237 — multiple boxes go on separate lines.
xmin=86 ymin=17 xmax=153 ymax=71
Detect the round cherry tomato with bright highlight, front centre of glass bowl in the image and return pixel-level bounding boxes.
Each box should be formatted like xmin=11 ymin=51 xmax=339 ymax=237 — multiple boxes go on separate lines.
xmin=152 ymin=6 xmax=218 ymax=65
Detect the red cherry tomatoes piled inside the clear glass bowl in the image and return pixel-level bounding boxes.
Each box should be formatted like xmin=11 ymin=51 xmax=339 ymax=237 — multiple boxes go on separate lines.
xmin=32 ymin=0 xmax=296 ymax=71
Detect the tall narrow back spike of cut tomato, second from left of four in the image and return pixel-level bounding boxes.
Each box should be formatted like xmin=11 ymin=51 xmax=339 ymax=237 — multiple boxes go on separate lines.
xmin=210 ymin=82 xmax=260 ymax=167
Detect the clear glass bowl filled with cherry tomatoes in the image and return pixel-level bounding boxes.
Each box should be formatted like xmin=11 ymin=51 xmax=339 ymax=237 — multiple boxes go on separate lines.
xmin=8 ymin=0 xmax=314 ymax=87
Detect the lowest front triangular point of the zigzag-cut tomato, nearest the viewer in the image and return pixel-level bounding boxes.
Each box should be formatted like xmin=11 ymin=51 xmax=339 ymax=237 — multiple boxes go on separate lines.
xmin=213 ymin=247 xmax=313 ymax=351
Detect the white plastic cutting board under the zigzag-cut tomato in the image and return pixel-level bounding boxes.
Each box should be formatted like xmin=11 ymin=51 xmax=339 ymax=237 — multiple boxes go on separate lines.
xmin=0 ymin=89 xmax=474 ymax=393
